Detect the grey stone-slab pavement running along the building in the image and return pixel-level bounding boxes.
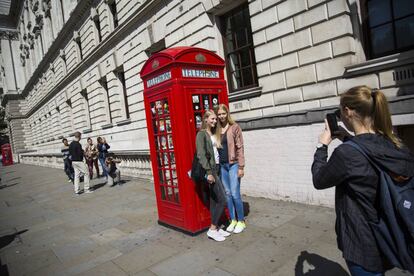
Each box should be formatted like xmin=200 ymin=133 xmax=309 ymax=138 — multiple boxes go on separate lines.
xmin=0 ymin=164 xmax=408 ymax=276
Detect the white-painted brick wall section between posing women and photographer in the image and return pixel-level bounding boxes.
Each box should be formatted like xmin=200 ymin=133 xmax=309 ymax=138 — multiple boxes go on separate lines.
xmin=241 ymin=124 xmax=337 ymax=206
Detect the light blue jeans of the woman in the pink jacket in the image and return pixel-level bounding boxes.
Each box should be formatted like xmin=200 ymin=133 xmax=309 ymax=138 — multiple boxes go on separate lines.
xmin=220 ymin=163 xmax=244 ymax=221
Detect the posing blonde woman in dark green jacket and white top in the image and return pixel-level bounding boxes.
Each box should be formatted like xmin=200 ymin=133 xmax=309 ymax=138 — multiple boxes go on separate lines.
xmin=196 ymin=110 xmax=230 ymax=241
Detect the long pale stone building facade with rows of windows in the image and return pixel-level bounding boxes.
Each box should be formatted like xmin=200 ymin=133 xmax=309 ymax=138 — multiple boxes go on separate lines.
xmin=0 ymin=0 xmax=414 ymax=205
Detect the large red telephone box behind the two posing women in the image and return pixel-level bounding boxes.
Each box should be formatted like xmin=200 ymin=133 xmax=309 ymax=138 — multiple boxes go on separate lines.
xmin=140 ymin=47 xmax=228 ymax=235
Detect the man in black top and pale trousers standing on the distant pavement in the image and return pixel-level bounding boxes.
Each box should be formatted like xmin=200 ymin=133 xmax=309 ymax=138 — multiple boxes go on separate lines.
xmin=69 ymin=131 xmax=92 ymax=194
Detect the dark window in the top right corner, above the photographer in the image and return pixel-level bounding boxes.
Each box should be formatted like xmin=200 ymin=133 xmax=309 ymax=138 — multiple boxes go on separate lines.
xmin=362 ymin=0 xmax=414 ymax=58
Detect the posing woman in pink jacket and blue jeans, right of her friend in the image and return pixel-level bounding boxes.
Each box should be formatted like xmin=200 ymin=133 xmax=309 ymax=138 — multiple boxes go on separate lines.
xmin=217 ymin=104 xmax=246 ymax=234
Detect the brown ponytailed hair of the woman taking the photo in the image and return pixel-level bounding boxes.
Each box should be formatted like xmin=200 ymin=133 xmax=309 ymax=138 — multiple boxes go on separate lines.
xmin=341 ymin=85 xmax=401 ymax=147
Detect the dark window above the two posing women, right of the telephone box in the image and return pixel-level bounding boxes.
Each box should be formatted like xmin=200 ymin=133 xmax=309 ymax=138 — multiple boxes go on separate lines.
xmin=221 ymin=4 xmax=257 ymax=92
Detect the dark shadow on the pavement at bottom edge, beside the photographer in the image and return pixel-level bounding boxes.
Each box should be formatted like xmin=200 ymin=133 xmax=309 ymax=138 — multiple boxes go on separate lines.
xmin=295 ymin=251 xmax=349 ymax=276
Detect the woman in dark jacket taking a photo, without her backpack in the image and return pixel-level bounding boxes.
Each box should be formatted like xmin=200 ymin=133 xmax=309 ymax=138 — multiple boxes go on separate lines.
xmin=312 ymin=86 xmax=414 ymax=276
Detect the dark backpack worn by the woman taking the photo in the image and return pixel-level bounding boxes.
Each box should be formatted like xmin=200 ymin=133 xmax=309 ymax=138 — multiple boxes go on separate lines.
xmin=345 ymin=141 xmax=414 ymax=273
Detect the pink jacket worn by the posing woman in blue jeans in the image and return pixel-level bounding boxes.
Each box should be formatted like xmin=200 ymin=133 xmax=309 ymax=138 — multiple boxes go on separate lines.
xmin=226 ymin=123 xmax=244 ymax=169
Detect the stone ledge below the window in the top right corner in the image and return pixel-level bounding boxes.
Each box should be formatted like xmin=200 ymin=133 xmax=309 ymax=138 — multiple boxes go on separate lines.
xmin=344 ymin=50 xmax=414 ymax=78
